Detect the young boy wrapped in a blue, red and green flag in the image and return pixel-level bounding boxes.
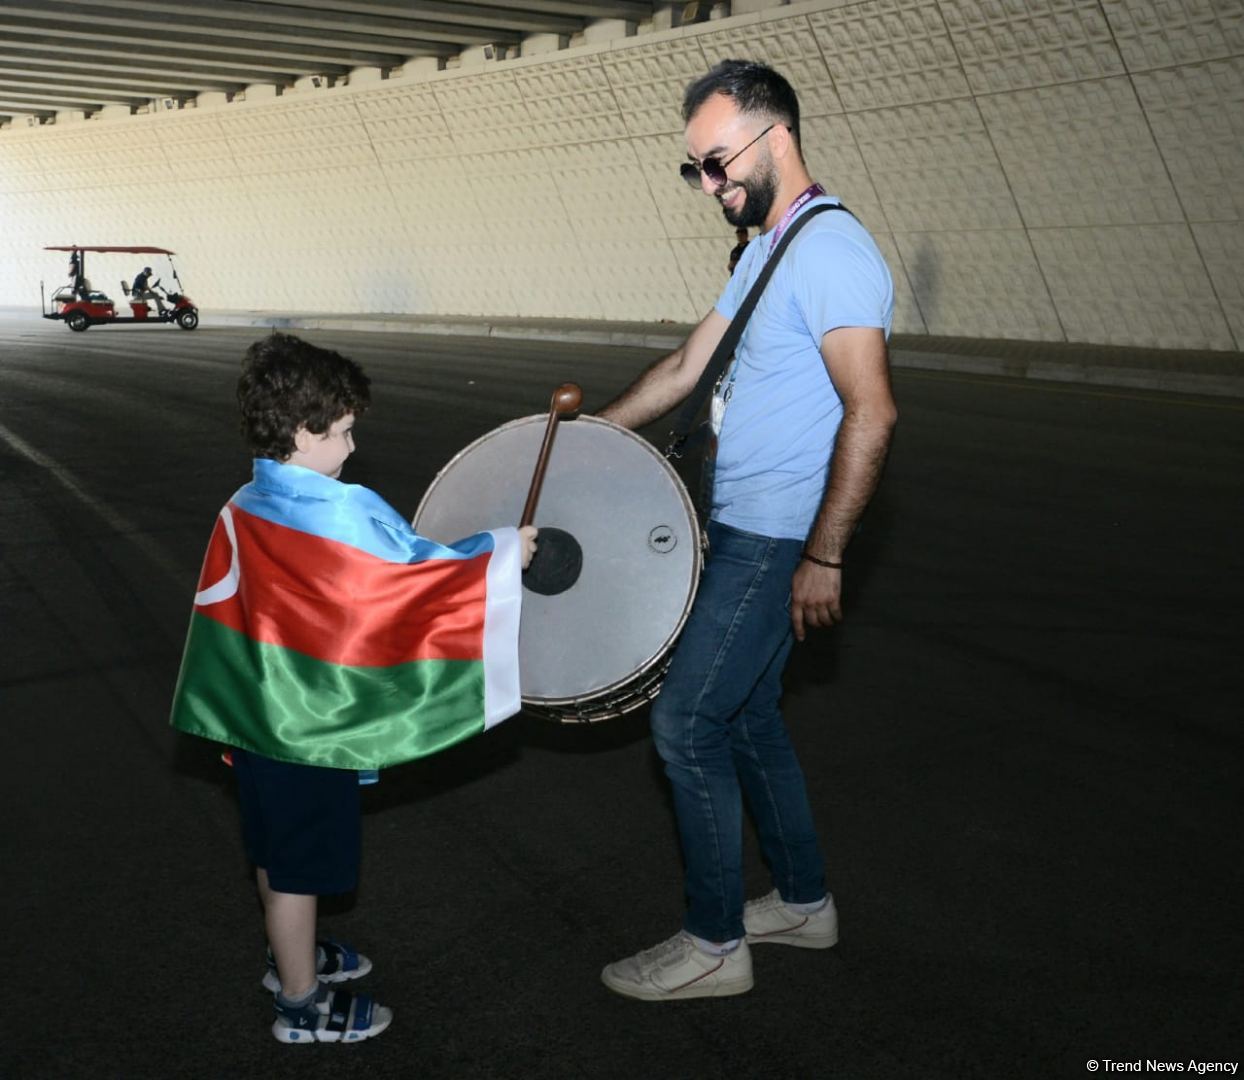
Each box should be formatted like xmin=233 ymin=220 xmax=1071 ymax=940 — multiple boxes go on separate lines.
xmin=172 ymin=333 xmax=535 ymax=1043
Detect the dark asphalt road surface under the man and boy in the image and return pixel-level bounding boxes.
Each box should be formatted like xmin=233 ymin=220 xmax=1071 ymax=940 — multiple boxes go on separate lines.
xmin=0 ymin=319 xmax=1244 ymax=1080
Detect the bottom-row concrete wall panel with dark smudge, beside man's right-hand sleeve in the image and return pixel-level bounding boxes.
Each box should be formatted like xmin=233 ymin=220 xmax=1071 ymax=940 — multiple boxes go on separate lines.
xmin=894 ymin=229 xmax=1061 ymax=340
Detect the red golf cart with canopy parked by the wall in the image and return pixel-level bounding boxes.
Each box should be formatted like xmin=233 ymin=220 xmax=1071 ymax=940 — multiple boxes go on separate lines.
xmin=39 ymin=244 xmax=199 ymax=331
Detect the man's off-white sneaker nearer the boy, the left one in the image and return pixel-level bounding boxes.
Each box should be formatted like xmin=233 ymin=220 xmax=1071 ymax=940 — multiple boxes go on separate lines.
xmin=601 ymin=931 xmax=753 ymax=1002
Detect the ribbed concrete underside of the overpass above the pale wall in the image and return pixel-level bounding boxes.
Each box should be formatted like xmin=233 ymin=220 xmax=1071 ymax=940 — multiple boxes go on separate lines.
xmin=0 ymin=0 xmax=657 ymax=121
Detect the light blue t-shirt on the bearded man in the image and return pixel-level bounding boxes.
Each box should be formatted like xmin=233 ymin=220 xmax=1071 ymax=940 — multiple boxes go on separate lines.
xmin=712 ymin=195 xmax=894 ymax=540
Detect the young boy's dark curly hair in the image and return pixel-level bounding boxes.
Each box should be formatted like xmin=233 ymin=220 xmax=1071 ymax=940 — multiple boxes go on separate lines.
xmin=238 ymin=333 xmax=372 ymax=462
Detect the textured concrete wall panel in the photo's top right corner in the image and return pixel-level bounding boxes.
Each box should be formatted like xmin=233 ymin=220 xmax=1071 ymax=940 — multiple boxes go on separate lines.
xmin=1102 ymin=0 xmax=1244 ymax=71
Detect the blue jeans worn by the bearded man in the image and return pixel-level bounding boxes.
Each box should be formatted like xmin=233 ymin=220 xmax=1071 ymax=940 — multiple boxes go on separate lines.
xmin=652 ymin=521 xmax=826 ymax=942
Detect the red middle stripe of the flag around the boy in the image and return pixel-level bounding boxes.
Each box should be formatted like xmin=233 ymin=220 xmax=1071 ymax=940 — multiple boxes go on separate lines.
xmin=197 ymin=504 xmax=490 ymax=667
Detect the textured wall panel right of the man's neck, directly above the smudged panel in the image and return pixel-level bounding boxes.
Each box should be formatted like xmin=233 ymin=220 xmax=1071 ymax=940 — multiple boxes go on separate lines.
xmin=850 ymin=101 xmax=1020 ymax=233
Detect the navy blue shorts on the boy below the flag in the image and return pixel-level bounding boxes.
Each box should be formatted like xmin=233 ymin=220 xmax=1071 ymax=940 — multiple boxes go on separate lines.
xmin=233 ymin=749 xmax=362 ymax=896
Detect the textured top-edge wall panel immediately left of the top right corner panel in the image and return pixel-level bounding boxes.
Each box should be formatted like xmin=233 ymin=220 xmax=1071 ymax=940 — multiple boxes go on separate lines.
xmin=940 ymin=0 xmax=1123 ymax=93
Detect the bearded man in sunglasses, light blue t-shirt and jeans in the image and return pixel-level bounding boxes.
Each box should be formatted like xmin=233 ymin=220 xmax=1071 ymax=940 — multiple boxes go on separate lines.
xmin=601 ymin=60 xmax=897 ymax=1000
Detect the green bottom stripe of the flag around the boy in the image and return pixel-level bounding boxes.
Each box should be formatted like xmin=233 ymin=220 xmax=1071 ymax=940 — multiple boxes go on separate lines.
xmin=172 ymin=612 xmax=484 ymax=769
